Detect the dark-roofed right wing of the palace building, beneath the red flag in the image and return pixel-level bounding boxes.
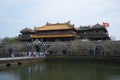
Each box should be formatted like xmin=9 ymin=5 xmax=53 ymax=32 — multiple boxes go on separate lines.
xmin=77 ymin=23 xmax=110 ymax=40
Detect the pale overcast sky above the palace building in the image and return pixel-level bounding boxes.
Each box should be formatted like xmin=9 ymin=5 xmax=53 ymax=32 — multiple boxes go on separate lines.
xmin=0 ymin=0 xmax=120 ymax=40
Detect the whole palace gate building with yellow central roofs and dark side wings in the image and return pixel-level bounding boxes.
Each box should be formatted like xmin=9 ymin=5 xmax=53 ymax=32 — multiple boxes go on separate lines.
xmin=18 ymin=21 xmax=110 ymax=41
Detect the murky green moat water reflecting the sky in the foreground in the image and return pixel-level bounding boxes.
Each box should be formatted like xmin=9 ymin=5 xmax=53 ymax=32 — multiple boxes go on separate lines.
xmin=0 ymin=62 xmax=120 ymax=80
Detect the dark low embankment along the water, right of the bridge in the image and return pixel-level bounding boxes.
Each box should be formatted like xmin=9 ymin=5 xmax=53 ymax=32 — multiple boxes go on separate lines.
xmin=46 ymin=56 xmax=120 ymax=64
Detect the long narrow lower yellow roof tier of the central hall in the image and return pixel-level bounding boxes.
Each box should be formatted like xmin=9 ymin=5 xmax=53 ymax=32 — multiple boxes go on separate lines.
xmin=31 ymin=34 xmax=75 ymax=38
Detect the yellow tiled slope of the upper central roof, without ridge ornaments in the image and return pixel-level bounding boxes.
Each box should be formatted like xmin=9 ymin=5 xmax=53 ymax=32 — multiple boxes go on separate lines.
xmin=35 ymin=24 xmax=73 ymax=31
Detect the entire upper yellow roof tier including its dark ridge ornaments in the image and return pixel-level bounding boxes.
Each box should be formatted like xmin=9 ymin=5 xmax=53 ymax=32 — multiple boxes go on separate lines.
xmin=35 ymin=21 xmax=74 ymax=31
